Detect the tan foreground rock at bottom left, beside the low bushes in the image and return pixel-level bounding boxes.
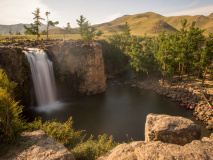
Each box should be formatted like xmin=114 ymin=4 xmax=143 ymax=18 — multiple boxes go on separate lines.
xmin=11 ymin=130 xmax=75 ymax=160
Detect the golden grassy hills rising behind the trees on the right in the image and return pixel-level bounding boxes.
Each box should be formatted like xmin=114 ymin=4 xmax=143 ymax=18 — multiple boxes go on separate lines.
xmin=94 ymin=12 xmax=213 ymax=35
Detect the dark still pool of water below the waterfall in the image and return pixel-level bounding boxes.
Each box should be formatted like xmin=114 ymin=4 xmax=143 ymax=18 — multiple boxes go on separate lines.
xmin=24 ymin=86 xmax=211 ymax=142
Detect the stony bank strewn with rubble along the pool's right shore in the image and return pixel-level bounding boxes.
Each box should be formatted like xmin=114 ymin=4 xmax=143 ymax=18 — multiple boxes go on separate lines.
xmin=128 ymin=81 xmax=213 ymax=129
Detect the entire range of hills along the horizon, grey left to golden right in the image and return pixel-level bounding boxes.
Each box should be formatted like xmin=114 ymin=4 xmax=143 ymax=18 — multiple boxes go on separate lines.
xmin=0 ymin=12 xmax=213 ymax=35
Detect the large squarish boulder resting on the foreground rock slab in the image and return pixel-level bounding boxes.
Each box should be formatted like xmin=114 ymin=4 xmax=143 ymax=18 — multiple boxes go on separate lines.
xmin=145 ymin=114 xmax=201 ymax=145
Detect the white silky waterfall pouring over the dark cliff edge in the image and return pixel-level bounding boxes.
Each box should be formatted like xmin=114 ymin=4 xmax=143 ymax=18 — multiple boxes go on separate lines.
xmin=25 ymin=48 xmax=56 ymax=106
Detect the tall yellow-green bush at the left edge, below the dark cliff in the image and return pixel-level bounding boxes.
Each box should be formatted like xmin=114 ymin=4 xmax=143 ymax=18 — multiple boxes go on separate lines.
xmin=0 ymin=69 xmax=24 ymax=143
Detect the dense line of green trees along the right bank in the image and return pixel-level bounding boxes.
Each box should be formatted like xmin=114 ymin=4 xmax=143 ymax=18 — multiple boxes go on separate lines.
xmin=108 ymin=19 xmax=213 ymax=83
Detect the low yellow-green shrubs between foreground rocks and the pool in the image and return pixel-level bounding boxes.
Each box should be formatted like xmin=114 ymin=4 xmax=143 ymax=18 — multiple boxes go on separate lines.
xmin=25 ymin=117 xmax=117 ymax=160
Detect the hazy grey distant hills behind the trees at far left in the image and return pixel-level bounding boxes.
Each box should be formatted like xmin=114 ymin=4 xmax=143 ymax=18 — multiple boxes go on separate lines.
xmin=0 ymin=23 xmax=58 ymax=35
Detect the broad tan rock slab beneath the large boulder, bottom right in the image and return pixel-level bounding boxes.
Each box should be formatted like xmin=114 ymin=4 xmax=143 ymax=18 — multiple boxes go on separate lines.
xmin=98 ymin=137 xmax=213 ymax=160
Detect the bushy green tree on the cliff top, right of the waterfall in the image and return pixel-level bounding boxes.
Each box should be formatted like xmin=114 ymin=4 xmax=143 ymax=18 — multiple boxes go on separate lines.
xmin=76 ymin=15 xmax=96 ymax=44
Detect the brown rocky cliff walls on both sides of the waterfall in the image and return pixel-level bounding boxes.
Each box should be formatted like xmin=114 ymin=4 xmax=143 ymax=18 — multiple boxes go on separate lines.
xmin=0 ymin=40 xmax=106 ymax=106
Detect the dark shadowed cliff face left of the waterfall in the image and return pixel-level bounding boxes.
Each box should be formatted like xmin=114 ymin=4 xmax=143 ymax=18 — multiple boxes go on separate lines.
xmin=0 ymin=47 xmax=31 ymax=106
